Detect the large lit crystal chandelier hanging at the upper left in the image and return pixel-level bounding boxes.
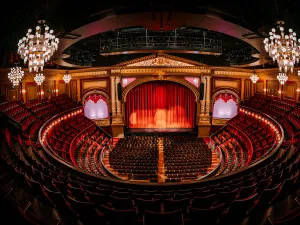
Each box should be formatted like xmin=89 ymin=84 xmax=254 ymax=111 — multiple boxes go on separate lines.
xmin=18 ymin=20 xmax=59 ymax=72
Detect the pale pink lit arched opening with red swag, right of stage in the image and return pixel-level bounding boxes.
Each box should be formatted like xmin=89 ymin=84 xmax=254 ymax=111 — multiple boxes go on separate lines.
xmin=213 ymin=93 xmax=238 ymax=119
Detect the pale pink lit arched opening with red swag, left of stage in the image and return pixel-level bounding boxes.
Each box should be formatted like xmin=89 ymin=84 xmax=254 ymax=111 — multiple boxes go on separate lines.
xmin=84 ymin=94 xmax=109 ymax=119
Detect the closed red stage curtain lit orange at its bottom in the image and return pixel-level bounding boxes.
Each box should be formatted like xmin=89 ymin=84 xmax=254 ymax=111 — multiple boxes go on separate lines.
xmin=126 ymin=81 xmax=196 ymax=128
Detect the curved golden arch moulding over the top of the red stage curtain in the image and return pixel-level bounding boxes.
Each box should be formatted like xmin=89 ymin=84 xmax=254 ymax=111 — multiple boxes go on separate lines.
xmin=122 ymin=77 xmax=200 ymax=102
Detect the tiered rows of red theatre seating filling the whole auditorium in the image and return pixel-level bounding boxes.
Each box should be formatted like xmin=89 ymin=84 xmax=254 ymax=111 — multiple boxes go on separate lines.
xmin=0 ymin=96 xmax=300 ymax=225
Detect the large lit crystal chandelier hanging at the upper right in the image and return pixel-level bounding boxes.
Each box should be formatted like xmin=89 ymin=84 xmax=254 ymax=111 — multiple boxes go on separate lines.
xmin=264 ymin=21 xmax=300 ymax=73
